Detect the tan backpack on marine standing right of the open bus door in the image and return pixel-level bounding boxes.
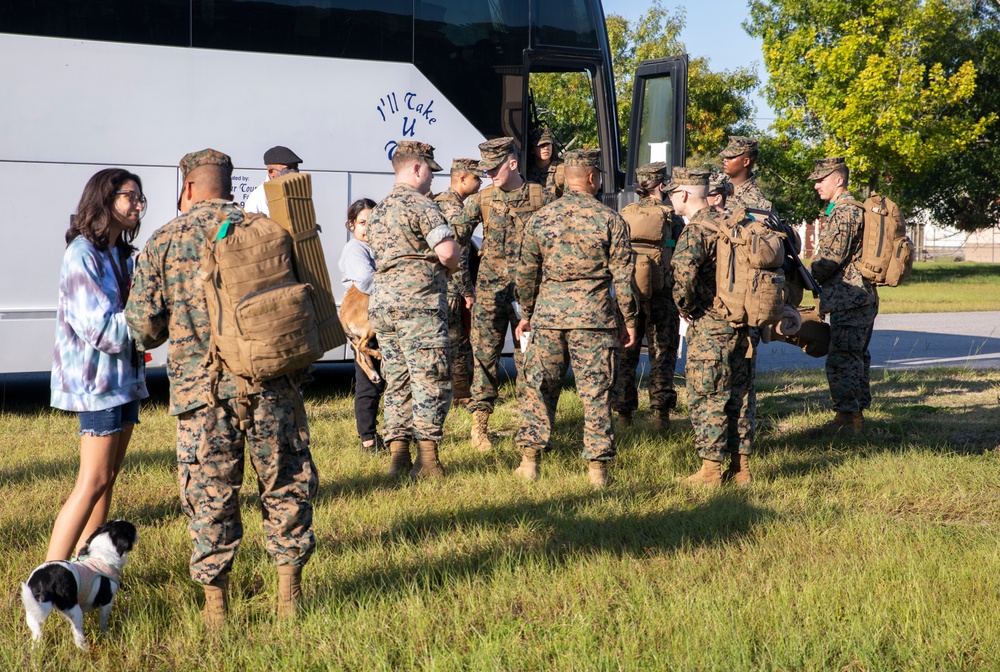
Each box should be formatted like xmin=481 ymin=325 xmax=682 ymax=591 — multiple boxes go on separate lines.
xmin=715 ymin=208 xmax=785 ymax=327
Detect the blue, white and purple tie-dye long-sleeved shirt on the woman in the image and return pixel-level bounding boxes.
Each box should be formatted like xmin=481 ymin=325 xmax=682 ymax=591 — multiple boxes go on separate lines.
xmin=50 ymin=236 xmax=149 ymax=412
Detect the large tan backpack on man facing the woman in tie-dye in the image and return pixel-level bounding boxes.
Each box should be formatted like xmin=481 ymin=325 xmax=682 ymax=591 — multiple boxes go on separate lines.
xmin=201 ymin=211 xmax=324 ymax=384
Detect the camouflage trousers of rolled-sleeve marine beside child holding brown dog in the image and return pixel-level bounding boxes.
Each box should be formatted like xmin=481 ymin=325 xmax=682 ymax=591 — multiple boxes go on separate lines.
xmin=369 ymin=306 xmax=451 ymax=443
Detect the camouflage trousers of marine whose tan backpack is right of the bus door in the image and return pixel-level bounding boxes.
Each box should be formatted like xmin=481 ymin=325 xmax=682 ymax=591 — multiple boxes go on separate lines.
xmin=685 ymin=317 xmax=757 ymax=462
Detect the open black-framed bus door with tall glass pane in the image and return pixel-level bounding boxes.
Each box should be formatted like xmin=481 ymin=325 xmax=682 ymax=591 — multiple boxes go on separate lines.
xmin=618 ymin=54 xmax=688 ymax=209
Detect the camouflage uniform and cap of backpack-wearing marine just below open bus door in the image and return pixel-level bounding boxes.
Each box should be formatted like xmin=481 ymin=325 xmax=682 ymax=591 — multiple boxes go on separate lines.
xmin=612 ymin=163 xmax=684 ymax=415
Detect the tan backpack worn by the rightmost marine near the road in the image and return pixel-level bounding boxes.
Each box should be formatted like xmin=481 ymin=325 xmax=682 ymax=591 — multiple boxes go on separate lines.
xmin=841 ymin=191 xmax=916 ymax=287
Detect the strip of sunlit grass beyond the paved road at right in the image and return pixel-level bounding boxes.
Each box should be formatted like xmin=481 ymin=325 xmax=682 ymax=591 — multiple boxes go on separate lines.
xmin=803 ymin=261 xmax=1000 ymax=314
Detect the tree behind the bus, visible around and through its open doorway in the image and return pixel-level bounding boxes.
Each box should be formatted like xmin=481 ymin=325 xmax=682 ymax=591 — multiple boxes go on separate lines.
xmin=531 ymin=0 xmax=758 ymax=163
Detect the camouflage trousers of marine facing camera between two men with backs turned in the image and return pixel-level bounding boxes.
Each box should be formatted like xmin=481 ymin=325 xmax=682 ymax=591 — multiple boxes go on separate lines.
xmin=467 ymin=284 xmax=524 ymax=413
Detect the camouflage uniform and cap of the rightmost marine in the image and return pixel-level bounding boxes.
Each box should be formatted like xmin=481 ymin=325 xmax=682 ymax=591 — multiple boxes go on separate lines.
xmin=809 ymin=159 xmax=878 ymax=413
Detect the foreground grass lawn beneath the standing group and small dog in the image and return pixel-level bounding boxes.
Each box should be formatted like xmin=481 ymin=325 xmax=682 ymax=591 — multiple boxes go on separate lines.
xmin=0 ymin=370 xmax=1000 ymax=671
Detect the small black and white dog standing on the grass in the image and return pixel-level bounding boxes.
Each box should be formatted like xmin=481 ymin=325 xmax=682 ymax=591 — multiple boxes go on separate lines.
xmin=21 ymin=520 xmax=139 ymax=650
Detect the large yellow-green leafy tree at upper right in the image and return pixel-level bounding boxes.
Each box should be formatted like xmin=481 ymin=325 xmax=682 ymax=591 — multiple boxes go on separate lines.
xmin=744 ymin=0 xmax=996 ymax=227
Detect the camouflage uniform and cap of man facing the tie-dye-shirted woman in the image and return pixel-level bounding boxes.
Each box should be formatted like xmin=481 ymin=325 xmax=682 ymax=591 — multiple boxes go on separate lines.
xmin=125 ymin=150 xmax=319 ymax=584
